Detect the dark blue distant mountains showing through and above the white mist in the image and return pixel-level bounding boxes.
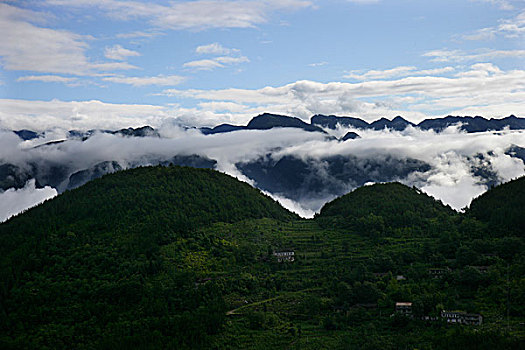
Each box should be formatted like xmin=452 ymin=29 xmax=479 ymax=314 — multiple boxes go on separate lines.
xmin=0 ymin=113 xmax=525 ymax=215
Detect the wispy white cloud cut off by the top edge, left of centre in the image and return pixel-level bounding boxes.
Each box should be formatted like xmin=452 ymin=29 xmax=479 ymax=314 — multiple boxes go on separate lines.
xmin=47 ymin=0 xmax=312 ymax=30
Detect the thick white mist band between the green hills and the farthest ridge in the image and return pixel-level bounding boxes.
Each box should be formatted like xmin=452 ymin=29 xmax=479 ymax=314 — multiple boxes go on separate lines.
xmin=0 ymin=122 xmax=525 ymax=219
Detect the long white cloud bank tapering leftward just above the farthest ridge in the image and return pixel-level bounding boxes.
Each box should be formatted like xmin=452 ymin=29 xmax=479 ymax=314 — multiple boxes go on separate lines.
xmin=163 ymin=64 xmax=525 ymax=122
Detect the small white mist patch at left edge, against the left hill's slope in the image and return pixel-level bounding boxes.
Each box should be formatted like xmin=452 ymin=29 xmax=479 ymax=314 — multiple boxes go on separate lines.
xmin=0 ymin=180 xmax=57 ymax=222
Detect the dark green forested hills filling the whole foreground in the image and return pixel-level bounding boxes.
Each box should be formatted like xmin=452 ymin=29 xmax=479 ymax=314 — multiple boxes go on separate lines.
xmin=0 ymin=166 xmax=525 ymax=349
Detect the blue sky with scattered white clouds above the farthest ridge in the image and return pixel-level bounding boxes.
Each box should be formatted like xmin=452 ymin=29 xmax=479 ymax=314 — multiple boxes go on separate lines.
xmin=0 ymin=0 xmax=525 ymax=130
